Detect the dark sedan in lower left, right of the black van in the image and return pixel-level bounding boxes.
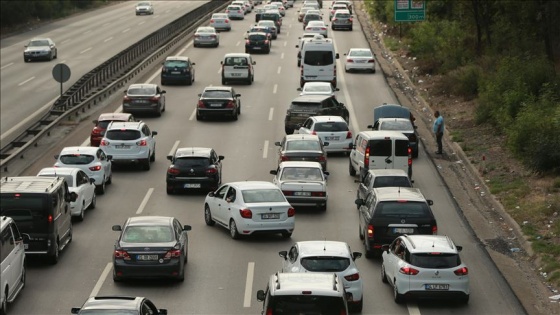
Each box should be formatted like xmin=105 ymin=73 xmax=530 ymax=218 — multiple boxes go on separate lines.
xmin=112 ymin=216 xmax=191 ymax=281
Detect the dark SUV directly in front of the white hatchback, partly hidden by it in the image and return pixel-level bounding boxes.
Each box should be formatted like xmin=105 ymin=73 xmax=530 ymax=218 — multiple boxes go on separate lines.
xmin=284 ymin=95 xmax=350 ymax=135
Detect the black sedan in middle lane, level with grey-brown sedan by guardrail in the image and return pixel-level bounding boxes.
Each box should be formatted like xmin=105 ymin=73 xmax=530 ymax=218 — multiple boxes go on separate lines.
xmin=196 ymin=86 xmax=241 ymax=120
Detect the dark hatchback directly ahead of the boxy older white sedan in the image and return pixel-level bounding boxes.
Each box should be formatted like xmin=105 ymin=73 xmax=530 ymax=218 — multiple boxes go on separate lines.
xmin=274 ymin=134 xmax=329 ymax=171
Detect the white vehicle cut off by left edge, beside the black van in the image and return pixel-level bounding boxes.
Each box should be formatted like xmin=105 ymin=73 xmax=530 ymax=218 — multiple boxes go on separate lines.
xmin=0 ymin=216 xmax=25 ymax=314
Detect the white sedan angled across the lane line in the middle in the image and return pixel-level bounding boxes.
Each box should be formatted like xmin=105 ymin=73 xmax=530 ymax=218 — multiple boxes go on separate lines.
xmin=204 ymin=181 xmax=296 ymax=239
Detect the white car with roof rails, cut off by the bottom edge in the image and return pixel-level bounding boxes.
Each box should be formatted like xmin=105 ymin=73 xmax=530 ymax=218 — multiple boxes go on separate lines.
xmin=257 ymin=272 xmax=348 ymax=314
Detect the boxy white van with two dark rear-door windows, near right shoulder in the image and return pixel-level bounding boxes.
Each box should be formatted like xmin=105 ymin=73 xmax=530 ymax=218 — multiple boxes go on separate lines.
xmin=348 ymin=131 xmax=412 ymax=178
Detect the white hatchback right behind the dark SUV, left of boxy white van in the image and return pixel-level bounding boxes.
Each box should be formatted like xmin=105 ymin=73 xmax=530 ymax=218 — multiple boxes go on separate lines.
xmin=298 ymin=116 xmax=353 ymax=154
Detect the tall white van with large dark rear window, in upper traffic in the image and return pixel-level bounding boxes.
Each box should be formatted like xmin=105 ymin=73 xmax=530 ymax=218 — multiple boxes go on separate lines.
xmin=299 ymin=38 xmax=339 ymax=87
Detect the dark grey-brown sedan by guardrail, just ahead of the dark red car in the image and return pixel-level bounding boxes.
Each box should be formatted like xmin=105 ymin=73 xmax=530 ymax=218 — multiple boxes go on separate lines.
xmin=122 ymin=83 xmax=166 ymax=116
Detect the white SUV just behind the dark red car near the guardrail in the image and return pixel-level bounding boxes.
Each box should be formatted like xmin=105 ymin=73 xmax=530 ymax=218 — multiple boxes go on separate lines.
xmin=100 ymin=121 xmax=157 ymax=171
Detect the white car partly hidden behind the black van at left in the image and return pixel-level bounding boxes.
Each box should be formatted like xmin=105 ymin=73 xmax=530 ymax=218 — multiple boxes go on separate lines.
xmin=37 ymin=167 xmax=96 ymax=221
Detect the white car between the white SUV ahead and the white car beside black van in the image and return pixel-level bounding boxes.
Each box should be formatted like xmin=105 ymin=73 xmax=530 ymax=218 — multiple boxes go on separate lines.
xmin=54 ymin=146 xmax=113 ymax=195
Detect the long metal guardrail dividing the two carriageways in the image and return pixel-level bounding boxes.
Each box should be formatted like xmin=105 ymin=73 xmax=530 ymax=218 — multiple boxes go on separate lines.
xmin=0 ymin=0 xmax=229 ymax=172
